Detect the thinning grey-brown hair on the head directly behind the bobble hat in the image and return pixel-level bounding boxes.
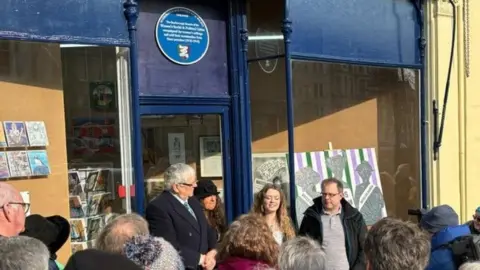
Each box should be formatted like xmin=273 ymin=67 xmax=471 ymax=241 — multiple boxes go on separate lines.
xmin=95 ymin=213 xmax=149 ymax=254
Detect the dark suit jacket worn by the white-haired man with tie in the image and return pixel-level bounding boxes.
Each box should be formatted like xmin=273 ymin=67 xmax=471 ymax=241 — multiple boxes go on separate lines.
xmin=146 ymin=191 xmax=217 ymax=269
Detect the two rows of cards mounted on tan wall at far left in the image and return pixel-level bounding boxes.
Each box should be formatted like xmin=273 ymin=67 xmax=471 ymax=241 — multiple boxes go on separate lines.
xmin=0 ymin=121 xmax=50 ymax=180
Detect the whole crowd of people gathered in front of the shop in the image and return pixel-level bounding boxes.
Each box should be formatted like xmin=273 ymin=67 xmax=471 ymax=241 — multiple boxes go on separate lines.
xmin=0 ymin=164 xmax=480 ymax=270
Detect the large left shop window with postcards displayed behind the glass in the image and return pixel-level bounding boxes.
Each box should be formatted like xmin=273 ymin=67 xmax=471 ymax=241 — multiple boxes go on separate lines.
xmin=0 ymin=40 xmax=132 ymax=262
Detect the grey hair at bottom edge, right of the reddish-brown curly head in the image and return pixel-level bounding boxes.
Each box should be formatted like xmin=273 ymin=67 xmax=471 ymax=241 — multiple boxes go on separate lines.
xmin=278 ymin=236 xmax=326 ymax=270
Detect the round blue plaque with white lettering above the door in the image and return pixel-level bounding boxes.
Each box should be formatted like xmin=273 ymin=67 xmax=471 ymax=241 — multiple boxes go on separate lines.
xmin=155 ymin=7 xmax=210 ymax=65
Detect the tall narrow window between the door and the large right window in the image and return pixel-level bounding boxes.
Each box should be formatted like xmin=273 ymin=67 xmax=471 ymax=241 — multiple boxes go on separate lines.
xmin=247 ymin=0 xmax=290 ymax=208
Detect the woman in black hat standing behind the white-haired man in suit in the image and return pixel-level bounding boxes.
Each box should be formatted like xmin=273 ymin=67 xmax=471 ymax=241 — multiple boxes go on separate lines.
xmin=194 ymin=180 xmax=227 ymax=241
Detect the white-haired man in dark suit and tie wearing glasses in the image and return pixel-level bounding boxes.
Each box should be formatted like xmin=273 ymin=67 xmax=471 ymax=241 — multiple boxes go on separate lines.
xmin=146 ymin=163 xmax=217 ymax=270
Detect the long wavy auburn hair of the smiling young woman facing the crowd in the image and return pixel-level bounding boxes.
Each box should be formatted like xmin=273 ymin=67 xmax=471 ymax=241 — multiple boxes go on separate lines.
xmin=252 ymin=184 xmax=295 ymax=240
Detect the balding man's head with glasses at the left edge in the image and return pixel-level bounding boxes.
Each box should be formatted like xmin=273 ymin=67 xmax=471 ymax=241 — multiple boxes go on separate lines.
xmin=0 ymin=182 xmax=30 ymax=237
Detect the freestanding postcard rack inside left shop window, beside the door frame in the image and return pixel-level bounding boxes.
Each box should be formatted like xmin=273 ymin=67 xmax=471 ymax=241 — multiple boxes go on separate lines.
xmin=68 ymin=163 xmax=115 ymax=253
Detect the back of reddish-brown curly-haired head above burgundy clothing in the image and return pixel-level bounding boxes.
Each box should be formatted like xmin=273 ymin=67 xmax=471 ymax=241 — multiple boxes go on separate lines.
xmin=217 ymin=214 xmax=278 ymax=266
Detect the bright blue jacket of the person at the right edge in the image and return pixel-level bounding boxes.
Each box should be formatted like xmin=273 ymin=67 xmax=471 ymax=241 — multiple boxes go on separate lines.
xmin=426 ymin=225 xmax=470 ymax=270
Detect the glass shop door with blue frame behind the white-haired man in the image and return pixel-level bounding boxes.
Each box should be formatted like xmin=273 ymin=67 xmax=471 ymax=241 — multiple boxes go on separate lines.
xmin=137 ymin=106 xmax=232 ymax=221
